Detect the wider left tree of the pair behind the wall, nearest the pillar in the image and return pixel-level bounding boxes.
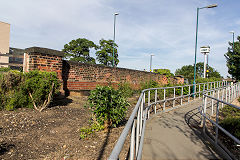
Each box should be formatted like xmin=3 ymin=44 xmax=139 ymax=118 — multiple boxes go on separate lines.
xmin=62 ymin=38 xmax=97 ymax=64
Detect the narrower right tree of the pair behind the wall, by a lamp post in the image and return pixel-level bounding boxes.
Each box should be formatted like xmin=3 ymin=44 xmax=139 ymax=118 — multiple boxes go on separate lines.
xmin=96 ymin=39 xmax=119 ymax=66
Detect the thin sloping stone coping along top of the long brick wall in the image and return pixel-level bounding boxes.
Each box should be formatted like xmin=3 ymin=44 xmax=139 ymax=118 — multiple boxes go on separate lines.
xmin=64 ymin=60 xmax=159 ymax=75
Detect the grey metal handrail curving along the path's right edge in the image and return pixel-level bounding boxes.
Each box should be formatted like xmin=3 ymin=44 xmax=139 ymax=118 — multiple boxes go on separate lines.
xmin=198 ymin=82 xmax=240 ymax=159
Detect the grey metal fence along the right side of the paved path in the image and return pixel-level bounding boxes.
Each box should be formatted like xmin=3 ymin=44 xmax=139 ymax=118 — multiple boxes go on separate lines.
xmin=199 ymin=82 xmax=240 ymax=159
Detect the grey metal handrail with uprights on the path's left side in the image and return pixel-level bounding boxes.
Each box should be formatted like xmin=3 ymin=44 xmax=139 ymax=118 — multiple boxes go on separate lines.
xmin=108 ymin=81 xmax=228 ymax=160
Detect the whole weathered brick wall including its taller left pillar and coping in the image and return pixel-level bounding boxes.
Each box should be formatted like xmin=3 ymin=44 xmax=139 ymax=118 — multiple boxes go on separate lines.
xmin=23 ymin=47 xmax=182 ymax=95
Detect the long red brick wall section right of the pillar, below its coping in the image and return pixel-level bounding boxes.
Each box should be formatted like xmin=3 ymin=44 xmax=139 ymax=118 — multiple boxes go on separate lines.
xmin=62 ymin=61 xmax=167 ymax=91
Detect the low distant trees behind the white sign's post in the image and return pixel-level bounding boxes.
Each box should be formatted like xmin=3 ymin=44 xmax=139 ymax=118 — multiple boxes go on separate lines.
xmin=175 ymin=62 xmax=221 ymax=80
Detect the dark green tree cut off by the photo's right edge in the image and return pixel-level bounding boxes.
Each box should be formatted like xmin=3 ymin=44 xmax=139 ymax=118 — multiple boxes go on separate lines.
xmin=224 ymin=36 xmax=240 ymax=80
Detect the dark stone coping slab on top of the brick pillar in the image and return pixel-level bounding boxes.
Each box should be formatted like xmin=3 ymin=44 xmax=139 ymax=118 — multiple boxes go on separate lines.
xmin=25 ymin=47 xmax=64 ymax=57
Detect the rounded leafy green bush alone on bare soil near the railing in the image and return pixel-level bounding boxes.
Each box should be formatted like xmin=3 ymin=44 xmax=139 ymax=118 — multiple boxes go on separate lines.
xmin=88 ymin=86 xmax=129 ymax=127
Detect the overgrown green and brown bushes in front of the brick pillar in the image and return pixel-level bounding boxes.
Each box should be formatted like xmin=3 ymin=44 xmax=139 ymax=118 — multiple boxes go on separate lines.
xmin=0 ymin=70 xmax=60 ymax=111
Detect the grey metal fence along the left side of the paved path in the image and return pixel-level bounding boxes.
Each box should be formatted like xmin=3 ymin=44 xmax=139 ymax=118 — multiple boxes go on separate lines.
xmin=108 ymin=81 xmax=228 ymax=160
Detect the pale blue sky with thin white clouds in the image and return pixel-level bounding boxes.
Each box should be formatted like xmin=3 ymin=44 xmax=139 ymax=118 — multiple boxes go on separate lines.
xmin=0 ymin=0 xmax=240 ymax=77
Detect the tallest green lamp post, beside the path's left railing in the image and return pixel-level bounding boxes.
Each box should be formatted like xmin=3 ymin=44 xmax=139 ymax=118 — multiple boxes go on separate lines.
xmin=193 ymin=4 xmax=217 ymax=95
